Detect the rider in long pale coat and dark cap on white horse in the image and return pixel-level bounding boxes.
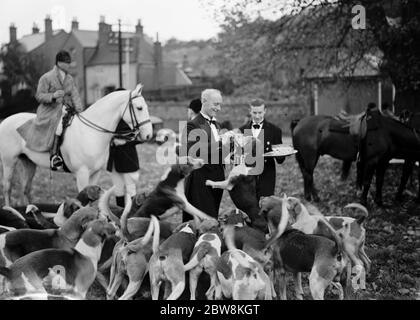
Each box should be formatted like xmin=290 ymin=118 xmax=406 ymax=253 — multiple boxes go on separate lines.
xmin=18 ymin=51 xmax=83 ymax=171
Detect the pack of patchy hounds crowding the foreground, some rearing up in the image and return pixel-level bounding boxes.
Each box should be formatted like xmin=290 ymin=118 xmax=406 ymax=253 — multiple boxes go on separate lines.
xmin=0 ymin=144 xmax=371 ymax=300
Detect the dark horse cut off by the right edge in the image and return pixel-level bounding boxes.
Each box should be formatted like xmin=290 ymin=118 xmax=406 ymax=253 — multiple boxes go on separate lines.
xmin=360 ymin=110 xmax=420 ymax=205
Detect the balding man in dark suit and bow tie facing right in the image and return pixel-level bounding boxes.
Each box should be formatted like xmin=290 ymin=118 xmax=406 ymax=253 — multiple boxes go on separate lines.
xmin=181 ymin=89 xmax=230 ymax=221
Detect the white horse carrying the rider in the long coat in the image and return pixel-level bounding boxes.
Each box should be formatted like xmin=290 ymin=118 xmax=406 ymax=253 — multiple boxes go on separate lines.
xmin=0 ymin=84 xmax=153 ymax=206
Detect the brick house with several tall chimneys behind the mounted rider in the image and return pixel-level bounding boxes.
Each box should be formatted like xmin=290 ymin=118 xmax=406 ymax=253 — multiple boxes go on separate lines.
xmin=5 ymin=16 xmax=192 ymax=105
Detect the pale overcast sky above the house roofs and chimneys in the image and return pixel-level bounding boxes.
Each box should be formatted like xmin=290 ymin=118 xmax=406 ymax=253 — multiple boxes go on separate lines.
xmin=0 ymin=0 xmax=220 ymax=43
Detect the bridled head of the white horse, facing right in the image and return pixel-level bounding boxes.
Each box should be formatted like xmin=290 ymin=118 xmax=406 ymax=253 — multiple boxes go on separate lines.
xmin=122 ymin=84 xmax=153 ymax=141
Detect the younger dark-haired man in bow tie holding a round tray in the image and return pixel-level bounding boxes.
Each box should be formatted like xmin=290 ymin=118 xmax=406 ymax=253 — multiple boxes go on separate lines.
xmin=239 ymin=99 xmax=285 ymax=199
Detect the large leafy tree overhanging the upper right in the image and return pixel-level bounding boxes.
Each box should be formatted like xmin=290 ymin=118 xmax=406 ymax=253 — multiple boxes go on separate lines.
xmin=207 ymin=0 xmax=420 ymax=112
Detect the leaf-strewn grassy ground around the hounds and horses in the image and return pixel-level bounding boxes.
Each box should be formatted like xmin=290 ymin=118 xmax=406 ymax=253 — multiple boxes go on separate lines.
xmin=0 ymin=144 xmax=420 ymax=300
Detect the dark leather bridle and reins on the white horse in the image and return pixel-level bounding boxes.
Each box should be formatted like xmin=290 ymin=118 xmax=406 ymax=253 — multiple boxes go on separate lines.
xmin=77 ymin=91 xmax=152 ymax=141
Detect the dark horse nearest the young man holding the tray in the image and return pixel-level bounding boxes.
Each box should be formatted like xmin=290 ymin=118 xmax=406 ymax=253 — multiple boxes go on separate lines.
xmin=291 ymin=115 xmax=362 ymax=201
